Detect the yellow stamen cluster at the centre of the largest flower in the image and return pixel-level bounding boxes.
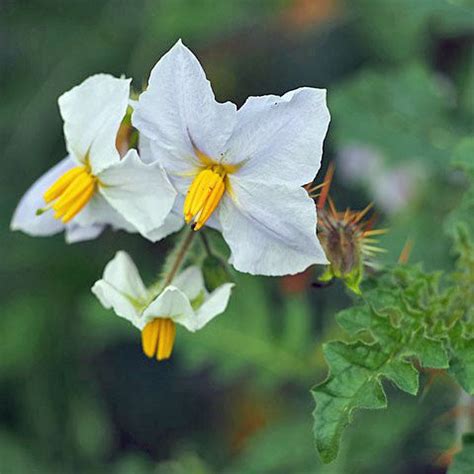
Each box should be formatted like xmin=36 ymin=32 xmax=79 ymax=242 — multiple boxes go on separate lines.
xmin=184 ymin=164 xmax=228 ymax=230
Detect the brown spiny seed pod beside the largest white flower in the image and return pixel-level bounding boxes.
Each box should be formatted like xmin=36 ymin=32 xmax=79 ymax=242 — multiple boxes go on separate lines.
xmin=309 ymin=166 xmax=386 ymax=294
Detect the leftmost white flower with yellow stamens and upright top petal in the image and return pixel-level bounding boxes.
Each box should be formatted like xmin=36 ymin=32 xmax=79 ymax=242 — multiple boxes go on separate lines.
xmin=11 ymin=74 xmax=181 ymax=242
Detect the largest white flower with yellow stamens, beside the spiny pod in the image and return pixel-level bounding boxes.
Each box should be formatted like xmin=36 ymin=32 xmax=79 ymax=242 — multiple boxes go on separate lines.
xmin=132 ymin=41 xmax=329 ymax=275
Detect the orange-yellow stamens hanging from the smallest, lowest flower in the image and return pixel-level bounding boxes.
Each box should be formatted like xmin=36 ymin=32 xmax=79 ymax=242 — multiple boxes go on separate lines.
xmin=142 ymin=318 xmax=176 ymax=360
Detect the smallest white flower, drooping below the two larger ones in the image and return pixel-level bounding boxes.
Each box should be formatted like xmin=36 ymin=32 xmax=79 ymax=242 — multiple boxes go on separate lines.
xmin=92 ymin=251 xmax=234 ymax=360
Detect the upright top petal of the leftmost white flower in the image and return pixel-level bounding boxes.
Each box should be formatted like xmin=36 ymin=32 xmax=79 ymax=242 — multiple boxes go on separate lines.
xmin=58 ymin=74 xmax=130 ymax=174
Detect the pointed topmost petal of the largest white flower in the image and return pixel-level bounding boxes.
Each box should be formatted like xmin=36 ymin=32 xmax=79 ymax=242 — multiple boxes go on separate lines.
xmin=132 ymin=41 xmax=236 ymax=186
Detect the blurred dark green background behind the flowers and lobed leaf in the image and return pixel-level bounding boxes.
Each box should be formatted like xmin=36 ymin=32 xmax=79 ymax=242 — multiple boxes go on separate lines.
xmin=0 ymin=0 xmax=474 ymax=474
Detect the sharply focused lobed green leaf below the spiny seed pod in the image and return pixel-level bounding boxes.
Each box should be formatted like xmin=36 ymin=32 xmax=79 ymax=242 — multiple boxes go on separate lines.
xmin=312 ymin=266 xmax=449 ymax=462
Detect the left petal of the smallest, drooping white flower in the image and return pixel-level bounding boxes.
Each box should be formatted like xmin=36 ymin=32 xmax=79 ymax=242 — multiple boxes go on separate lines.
xmin=92 ymin=251 xmax=148 ymax=329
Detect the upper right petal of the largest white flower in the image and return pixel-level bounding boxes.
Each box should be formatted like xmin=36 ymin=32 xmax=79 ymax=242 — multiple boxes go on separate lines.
xmin=225 ymin=87 xmax=330 ymax=186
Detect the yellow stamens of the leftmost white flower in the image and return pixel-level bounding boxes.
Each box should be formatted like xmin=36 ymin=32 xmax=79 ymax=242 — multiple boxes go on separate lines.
xmin=43 ymin=166 xmax=97 ymax=223
